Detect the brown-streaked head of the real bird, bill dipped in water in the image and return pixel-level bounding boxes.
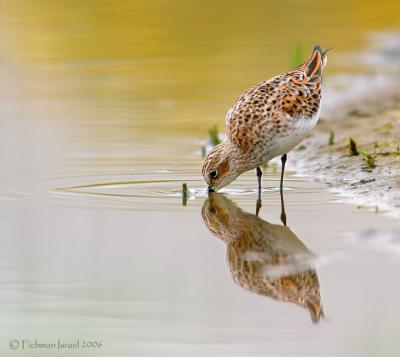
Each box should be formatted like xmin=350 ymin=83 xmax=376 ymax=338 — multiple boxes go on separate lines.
xmin=202 ymin=142 xmax=245 ymax=192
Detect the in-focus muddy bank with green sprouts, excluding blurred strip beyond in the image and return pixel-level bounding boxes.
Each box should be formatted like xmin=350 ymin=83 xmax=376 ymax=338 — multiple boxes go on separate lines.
xmin=290 ymin=88 xmax=400 ymax=216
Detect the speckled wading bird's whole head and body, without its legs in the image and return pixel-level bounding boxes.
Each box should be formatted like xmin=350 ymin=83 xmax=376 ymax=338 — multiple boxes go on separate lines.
xmin=203 ymin=46 xmax=327 ymax=190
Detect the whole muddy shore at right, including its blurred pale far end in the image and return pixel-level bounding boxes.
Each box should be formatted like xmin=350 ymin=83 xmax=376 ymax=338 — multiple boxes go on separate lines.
xmin=289 ymin=30 xmax=400 ymax=216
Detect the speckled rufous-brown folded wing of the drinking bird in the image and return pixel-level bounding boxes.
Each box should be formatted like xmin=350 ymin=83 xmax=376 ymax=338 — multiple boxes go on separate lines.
xmin=226 ymin=70 xmax=321 ymax=152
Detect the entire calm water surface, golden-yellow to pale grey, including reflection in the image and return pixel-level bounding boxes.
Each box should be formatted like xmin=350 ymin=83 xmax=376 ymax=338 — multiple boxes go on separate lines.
xmin=0 ymin=1 xmax=400 ymax=356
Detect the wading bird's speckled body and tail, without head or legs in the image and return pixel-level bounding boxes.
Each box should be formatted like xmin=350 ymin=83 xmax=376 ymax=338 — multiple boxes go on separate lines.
xmin=226 ymin=46 xmax=326 ymax=161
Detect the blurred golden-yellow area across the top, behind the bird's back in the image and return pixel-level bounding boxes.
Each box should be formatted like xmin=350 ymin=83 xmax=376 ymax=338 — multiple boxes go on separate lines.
xmin=0 ymin=0 xmax=400 ymax=135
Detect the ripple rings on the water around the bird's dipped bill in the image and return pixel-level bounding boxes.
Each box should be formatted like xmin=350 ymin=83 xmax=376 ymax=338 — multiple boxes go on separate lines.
xmin=52 ymin=171 xmax=332 ymax=209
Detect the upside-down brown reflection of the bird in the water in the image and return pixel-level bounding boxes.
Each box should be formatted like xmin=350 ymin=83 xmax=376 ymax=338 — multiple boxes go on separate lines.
xmin=202 ymin=192 xmax=324 ymax=322
